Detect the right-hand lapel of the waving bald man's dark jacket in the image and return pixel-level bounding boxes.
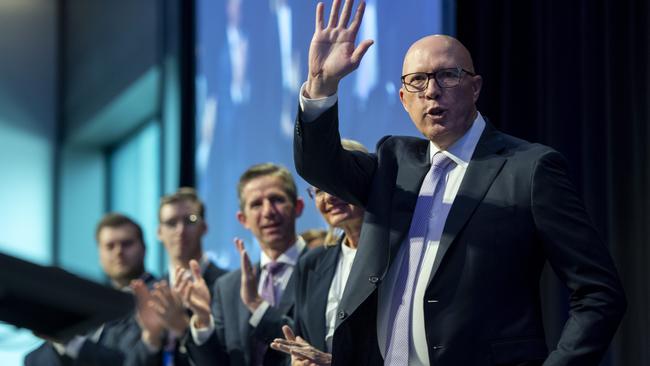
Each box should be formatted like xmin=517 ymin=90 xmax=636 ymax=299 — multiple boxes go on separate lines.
xmin=429 ymin=123 xmax=506 ymax=283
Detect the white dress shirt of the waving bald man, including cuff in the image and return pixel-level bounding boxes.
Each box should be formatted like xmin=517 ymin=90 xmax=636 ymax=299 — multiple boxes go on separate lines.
xmin=300 ymin=84 xmax=485 ymax=366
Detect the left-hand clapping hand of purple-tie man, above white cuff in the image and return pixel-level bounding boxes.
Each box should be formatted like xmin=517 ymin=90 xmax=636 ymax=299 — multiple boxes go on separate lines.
xmin=173 ymin=259 xmax=211 ymax=328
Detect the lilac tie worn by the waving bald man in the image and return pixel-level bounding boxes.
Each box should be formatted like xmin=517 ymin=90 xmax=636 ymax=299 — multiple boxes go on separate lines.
xmin=385 ymin=152 xmax=452 ymax=366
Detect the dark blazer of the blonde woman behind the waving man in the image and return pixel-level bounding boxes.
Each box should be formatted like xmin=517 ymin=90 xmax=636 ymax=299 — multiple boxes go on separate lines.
xmin=293 ymin=236 xmax=344 ymax=351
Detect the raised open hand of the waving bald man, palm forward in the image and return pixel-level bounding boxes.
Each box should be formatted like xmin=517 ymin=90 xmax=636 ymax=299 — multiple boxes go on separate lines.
xmin=305 ymin=0 xmax=373 ymax=98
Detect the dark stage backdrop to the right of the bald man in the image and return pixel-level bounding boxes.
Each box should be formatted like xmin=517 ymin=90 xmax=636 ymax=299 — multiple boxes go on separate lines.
xmin=457 ymin=0 xmax=650 ymax=366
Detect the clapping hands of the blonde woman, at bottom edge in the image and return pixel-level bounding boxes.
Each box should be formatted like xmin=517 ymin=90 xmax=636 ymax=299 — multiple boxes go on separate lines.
xmin=271 ymin=325 xmax=332 ymax=366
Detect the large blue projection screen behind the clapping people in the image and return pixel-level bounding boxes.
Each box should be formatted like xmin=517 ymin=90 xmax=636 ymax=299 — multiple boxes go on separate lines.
xmin=196 ymin=0 xmax=453 ymax=268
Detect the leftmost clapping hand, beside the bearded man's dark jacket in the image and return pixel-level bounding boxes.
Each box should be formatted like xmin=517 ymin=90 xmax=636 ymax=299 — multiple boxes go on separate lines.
xmin=131 ymin=280 xmax=165 ymax=348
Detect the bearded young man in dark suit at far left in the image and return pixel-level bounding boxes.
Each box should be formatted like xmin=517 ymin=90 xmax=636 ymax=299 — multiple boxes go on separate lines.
xmin=25 ymin=213 xmax=154 ymax=366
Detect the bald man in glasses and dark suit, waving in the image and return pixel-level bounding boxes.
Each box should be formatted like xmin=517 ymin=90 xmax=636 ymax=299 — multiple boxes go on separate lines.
xmin=294 ymin=0 xmax=626 ymax=366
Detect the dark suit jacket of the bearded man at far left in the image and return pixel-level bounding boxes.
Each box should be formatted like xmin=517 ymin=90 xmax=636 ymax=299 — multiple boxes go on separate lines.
xmin=25 ymin=274 xmax=155 ymax=366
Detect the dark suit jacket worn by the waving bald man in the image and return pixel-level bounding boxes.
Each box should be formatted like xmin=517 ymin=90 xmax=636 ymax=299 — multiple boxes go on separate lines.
xmin=294 ymin=106 xmax=626 ymax=366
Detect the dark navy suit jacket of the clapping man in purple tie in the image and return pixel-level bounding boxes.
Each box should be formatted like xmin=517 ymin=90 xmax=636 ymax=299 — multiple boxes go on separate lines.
xmin=188 ymin=254 xmax=306 ymax=366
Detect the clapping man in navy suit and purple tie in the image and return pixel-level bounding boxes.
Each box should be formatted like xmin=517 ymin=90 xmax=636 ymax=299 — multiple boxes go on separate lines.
xmin=188 ymin=163 xmax=306 ymax=366
